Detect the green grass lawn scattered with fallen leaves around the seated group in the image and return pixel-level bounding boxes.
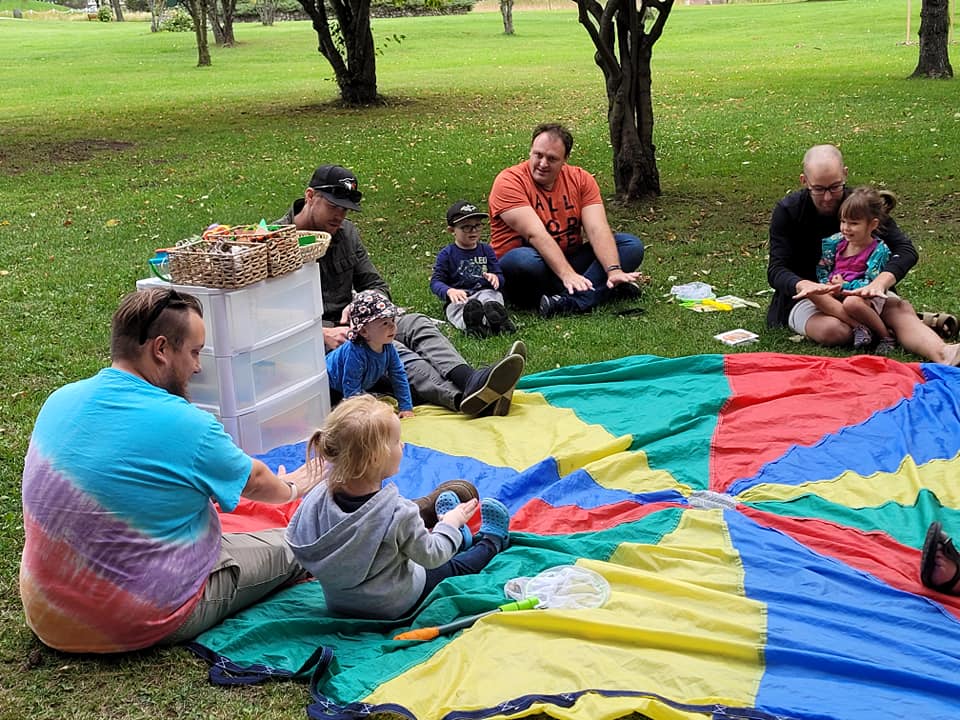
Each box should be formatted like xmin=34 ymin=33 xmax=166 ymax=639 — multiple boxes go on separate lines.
xmin=0 ymin=0 xmax=960 ymax=719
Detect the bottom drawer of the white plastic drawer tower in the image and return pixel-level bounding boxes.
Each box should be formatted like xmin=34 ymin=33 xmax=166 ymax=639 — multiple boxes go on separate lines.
xmin=216 ymin=369 xmax=330 ymax=455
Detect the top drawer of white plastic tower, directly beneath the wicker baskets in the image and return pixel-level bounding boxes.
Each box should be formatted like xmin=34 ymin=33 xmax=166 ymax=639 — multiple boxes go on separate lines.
xmin=137 ymin=263 xmax=323 ymax=357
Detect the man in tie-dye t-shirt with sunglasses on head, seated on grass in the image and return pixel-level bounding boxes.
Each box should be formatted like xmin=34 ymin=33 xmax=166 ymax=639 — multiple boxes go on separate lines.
xmin=20 ymin=288 xmax=311 ymax=652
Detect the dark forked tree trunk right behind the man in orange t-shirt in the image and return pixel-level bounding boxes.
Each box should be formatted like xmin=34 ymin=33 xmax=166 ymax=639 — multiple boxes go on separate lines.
xmin=576 ymin=0 xmax=673 ymax=201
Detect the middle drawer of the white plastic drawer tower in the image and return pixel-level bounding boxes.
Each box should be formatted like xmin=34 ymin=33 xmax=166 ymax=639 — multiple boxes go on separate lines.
xmin=189 ymin=321 xmax=326 ymax=417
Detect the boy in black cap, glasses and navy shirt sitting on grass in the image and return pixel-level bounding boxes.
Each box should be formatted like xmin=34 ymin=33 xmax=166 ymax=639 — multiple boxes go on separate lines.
xmin=430 ymin=200 xmax=516 ymax=337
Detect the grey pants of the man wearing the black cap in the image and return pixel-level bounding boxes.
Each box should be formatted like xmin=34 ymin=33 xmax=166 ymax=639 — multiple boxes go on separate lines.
xmin=394 ymin=313 xmax=467 ymax=410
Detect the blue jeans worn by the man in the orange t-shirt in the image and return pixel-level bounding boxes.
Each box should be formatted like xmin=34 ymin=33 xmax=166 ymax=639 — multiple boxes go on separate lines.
xmin=500 ymin=233 xmax=643 ymax=312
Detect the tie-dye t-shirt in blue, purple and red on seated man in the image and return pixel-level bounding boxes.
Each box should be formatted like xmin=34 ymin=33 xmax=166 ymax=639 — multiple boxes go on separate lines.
xmin=20 ymin=368 xmax=252 ymax=652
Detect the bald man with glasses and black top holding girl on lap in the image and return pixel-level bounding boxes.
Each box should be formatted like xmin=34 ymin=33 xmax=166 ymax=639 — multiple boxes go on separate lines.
xmin=767 ymin=145 xmax=960 ymax=365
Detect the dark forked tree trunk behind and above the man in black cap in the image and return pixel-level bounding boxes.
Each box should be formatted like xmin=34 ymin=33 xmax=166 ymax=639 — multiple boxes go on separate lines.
xmin=299 ymin=0 xmax=383 ymax=105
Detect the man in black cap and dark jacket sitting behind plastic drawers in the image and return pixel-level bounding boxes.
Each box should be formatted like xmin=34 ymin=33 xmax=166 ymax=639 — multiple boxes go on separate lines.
xmin=277 ymin=165 xmax=526 ymax=416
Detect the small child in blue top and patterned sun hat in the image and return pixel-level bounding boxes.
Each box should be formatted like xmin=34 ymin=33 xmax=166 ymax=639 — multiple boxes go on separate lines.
xmin=327 ymin=290 xmax=413 ymax=418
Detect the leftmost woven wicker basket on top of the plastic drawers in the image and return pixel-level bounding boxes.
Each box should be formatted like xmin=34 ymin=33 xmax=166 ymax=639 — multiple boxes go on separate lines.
xmin=168 ymin=239 xmax=267 ymax=288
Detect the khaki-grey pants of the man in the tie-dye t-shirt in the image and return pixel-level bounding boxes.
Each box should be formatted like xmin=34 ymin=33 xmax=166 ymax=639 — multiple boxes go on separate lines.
xmin=160 ymin=528 xmax=307 ymax=645
